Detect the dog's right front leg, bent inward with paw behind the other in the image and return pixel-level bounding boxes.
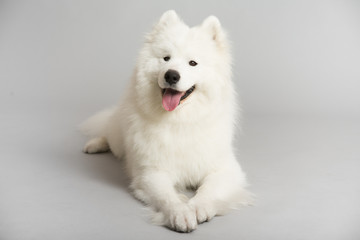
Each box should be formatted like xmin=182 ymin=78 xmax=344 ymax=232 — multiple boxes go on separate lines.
xmin=189 ymin=166 xmax=249 ymax=224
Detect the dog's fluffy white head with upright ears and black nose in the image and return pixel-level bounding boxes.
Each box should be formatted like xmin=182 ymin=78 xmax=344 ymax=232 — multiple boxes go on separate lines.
xmin=138 ymin=11 xmax=230 ymax=115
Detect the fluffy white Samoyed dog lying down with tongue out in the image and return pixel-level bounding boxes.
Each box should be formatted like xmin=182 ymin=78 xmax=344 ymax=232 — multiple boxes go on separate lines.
xmin=82 ymin=10 xmax=250 ymax=232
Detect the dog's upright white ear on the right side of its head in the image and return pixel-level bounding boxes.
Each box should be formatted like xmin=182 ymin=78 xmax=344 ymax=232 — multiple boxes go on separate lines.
xmin=201 ymin=16 xmax=227 ymax=48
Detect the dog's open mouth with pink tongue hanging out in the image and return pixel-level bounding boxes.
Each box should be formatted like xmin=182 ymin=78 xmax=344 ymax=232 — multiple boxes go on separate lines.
xmin=162 ymin=85 xmax=195 ymax=111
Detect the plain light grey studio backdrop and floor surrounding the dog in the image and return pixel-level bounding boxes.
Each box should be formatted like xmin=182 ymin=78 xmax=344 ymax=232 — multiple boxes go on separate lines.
xmin=0 ymin=0 xmax=360 ymax=240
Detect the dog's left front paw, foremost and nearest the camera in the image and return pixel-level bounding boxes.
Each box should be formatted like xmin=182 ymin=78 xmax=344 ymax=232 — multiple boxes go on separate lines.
xmin=165 ymin=203 xmax=197 ymax=232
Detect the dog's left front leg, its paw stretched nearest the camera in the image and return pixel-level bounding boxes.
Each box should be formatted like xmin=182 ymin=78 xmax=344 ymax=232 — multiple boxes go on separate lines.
xmin=132 ymin=170 xmax=197 ymax=232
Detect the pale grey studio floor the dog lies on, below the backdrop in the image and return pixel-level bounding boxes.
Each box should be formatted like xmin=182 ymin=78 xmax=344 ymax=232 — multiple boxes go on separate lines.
xmin=0 ymin=111 xmax=360 ymax=240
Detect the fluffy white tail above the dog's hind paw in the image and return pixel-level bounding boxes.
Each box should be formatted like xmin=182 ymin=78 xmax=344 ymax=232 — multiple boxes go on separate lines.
xmin=79 ymin=107 xmax=116 ymax=137
